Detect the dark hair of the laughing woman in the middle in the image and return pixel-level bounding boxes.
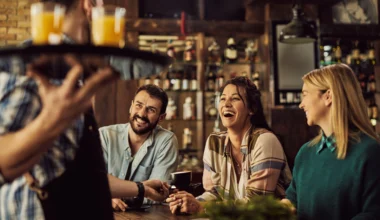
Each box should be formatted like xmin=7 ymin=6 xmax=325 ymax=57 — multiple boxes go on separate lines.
xmin=219 ymin=76 xmax=272 ymax=131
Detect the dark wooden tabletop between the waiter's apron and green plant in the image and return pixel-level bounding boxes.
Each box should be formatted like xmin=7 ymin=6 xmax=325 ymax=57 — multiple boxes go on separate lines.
xmin=114 ymin=205 xmax=196 ymax=220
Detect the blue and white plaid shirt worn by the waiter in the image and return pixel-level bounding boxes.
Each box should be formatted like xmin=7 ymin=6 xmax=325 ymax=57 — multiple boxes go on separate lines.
xmin=0 ymin=60 xmax=83 ymax=220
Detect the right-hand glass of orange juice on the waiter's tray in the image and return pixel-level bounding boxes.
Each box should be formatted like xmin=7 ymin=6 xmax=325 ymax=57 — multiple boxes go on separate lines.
xmin=91 ymin=6 xmax=126 ymax=47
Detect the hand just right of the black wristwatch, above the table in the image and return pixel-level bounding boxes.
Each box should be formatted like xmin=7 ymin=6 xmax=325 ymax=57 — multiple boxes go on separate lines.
xmin=143 ymin=180 xmax=169 ymax=201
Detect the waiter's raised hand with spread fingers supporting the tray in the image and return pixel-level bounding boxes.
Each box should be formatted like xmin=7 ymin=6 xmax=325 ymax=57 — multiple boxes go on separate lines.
xmin=27 ymin=61 xmax=117 ymax=136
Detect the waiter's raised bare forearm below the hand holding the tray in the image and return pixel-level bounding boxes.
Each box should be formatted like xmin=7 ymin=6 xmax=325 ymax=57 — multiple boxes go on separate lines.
xmin=0 ymin=111 xmax=57 ymax=181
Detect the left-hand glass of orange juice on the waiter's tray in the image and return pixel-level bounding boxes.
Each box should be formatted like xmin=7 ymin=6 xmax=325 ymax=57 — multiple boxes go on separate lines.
xmin=30 ymin=2 xmax=66 ymax=44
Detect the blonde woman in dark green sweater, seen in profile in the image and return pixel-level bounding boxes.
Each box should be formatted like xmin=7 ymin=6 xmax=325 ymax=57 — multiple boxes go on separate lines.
xmin=286 ymin=64 xmax=380 ymax=220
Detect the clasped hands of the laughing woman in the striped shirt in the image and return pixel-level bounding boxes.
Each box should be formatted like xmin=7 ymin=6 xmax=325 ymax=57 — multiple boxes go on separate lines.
xmin=166 ymin=191 xmax=203 ymax=214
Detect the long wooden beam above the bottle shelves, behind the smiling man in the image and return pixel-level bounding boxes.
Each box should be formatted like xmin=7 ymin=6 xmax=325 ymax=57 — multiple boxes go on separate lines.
xmin=126 ymin=19 xmax=264 ymax=36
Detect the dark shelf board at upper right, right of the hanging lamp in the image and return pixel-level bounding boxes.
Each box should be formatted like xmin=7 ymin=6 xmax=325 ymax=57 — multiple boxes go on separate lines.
xmin=320 ymin=24 xmax=380 ymax=40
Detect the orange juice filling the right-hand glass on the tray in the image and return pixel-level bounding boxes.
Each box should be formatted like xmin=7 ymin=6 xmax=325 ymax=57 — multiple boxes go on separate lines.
xmin=92 ymin=15 xmax=125 ymax=47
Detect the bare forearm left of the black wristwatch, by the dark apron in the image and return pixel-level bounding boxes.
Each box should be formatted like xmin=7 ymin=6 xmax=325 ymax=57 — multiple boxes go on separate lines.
xmin=108 ymin=174 xmax=138 ymax=198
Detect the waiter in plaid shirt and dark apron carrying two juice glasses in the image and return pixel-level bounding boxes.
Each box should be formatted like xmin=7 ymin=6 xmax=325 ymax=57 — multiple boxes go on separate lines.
xmin=0 ymin=0 xmax=168 ymax=219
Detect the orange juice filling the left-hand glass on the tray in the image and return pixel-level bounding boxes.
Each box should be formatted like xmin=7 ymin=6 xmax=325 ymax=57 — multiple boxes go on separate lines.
xmin=31 ymin=12 xmax=64 ymax=44
